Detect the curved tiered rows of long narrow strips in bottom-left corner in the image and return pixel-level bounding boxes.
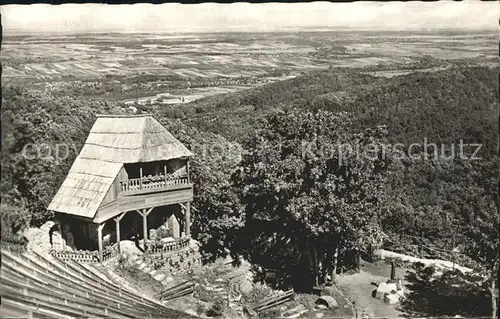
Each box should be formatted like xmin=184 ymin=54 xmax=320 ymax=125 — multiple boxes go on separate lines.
xmin=0 ymin=250 xmax=194 ymax=318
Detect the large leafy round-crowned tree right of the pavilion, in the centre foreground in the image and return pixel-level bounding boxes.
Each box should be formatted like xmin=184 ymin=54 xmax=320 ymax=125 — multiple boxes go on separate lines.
xmin=233 ymin=110 xmax=391 ymax=290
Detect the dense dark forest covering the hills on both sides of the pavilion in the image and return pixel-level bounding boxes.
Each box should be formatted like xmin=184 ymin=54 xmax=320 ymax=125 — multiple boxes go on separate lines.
xmin=1 ymin=65 xmax=499 ymax=314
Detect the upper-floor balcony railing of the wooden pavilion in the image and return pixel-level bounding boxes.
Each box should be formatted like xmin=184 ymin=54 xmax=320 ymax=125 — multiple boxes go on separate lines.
xmin=120 ymin=174 xmax=189 ymax=192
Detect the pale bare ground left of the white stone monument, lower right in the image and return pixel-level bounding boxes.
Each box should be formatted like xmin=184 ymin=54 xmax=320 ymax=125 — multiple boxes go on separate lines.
xmin=337 ymin=263 xmax=404 ymax=318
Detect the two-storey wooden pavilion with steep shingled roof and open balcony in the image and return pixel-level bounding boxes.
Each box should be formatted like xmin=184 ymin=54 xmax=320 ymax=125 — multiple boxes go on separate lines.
xmin=48 ymin=114 xmax=193 ymax=261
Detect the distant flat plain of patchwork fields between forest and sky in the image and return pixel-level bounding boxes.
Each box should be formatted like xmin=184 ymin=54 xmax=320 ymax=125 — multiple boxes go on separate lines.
xmin=2 ymin=31 xmax=497 ymax=104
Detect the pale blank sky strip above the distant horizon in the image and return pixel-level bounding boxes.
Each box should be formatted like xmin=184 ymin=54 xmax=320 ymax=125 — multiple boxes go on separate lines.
xmin=0 ymin=0 xmax=500 ymax=35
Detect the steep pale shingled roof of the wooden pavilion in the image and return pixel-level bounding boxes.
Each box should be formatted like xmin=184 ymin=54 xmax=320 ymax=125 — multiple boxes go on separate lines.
xmin=48 ymin=114 xmax=193 ymax=218
